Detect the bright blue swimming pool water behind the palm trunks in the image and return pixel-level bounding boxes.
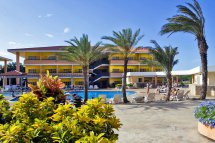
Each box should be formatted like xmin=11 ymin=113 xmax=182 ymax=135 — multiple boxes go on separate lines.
xmin=68 ymin=91 xmax=136 ymax=99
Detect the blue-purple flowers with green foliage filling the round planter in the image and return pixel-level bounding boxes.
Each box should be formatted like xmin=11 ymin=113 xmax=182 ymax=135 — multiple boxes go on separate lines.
xmin=194 ymin=101 xmax=215 ymax=128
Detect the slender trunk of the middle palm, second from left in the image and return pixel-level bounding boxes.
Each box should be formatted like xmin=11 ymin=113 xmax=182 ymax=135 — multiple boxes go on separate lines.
xmin=122 ymin=58 xmax=129 ymax=103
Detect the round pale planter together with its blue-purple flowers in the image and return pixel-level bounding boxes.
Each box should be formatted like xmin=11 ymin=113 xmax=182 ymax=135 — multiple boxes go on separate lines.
xmin=194 ymin=101 xmax=215 ymax=140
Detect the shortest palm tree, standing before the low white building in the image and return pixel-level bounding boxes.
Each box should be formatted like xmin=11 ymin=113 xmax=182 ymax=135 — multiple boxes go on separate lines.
xmin=141 ymin=40 xmax=179 ymax=101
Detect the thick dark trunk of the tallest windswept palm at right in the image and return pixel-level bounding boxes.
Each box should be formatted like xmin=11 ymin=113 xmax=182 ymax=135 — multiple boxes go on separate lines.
xmin=198 ymin=38 xmax=208 ymax=100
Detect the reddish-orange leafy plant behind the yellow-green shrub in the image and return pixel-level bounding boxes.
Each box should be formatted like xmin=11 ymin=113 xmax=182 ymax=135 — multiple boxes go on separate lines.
xmin=28 ymin=71 xmax=66 ymax=103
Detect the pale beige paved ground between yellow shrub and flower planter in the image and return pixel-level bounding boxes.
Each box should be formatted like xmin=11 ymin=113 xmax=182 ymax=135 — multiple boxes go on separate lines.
xmin=114 ymin=101 xmax=214 ymax=143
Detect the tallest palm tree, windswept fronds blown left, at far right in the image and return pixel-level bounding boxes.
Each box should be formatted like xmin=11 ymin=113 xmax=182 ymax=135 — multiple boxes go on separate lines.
xmin=160 ymin=0 xmax=208 ymax=99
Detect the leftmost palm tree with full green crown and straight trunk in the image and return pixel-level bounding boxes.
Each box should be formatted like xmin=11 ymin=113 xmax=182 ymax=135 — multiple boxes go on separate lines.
xmin=61 ymin=34 xmax=103 ymax=102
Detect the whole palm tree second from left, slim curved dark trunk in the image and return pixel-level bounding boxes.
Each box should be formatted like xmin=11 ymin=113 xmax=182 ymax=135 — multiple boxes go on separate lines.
xmin=102 ymin=28 xmax=143 ymax=103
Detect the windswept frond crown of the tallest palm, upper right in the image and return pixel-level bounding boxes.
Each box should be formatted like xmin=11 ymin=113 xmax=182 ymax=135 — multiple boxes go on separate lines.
xmin=160 ymin=0 xmax=205 ymax=37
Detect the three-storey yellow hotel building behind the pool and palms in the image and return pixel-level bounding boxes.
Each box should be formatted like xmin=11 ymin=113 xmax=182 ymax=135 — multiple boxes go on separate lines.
xmin=8 ymin=46 xmax=162 ymax=88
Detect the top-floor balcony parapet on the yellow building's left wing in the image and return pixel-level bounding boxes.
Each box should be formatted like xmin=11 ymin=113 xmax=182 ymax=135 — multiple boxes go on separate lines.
xmin=24 ymin=60 xmax=76 ymax=65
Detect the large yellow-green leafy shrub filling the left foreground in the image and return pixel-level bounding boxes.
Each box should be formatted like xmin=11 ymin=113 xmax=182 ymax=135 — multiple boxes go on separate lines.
xmin=0 ymin=93 xmax=121 ymax=143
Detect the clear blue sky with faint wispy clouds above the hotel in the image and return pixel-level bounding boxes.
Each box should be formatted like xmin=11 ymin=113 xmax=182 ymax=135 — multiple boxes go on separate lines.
xmin=0 ymin=0 xmax=215 ymax=70
